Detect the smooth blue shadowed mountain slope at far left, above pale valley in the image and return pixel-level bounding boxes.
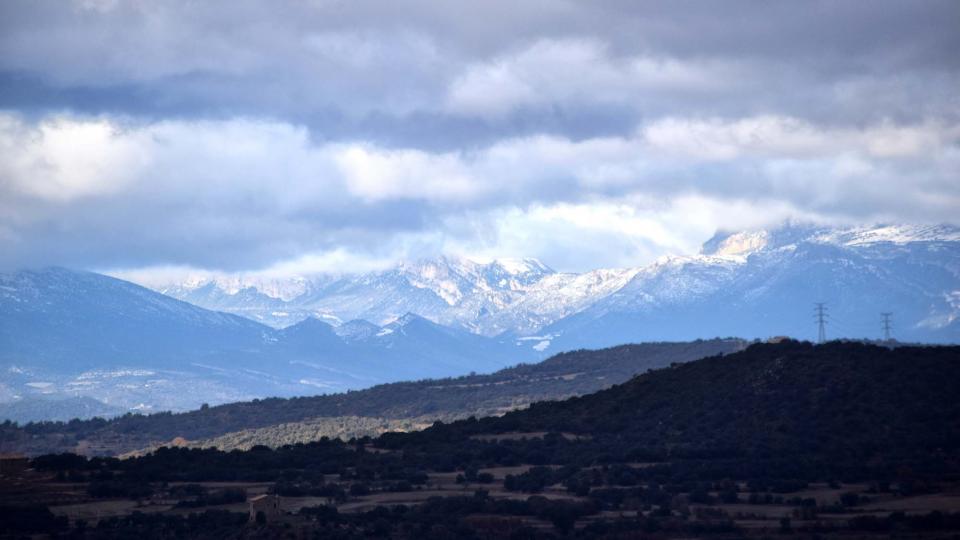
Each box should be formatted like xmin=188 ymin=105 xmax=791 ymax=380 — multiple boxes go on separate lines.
xmin=0 ymin=268 xmax=269 ymax=371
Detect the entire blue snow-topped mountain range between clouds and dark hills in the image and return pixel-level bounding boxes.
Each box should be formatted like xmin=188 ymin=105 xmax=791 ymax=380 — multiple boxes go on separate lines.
xmin=0 ymin=224 xmax=960 ymax=418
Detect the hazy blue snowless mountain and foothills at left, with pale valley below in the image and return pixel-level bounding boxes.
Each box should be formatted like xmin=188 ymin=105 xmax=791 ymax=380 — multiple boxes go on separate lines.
xmin=0 ymin=268 xmax=540 ymax=411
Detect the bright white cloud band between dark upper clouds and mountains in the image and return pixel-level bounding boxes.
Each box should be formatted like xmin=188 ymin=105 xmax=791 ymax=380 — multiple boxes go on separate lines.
xmin=0 ymin=113 xmax=960 ymax=271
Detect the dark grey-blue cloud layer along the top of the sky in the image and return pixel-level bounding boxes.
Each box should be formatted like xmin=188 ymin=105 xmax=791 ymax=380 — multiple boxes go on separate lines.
xmin=0 ymin=0 xmax=960 ymax=133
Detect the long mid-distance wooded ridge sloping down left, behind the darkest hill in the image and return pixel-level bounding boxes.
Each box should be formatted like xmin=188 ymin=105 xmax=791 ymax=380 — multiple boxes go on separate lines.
xmin=0 ymin=339 xmax=746 ymax=454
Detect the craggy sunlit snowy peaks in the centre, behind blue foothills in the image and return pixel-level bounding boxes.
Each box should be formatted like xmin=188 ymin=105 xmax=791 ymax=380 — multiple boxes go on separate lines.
xmin=153 ymin=257 xmax=576 ymax=335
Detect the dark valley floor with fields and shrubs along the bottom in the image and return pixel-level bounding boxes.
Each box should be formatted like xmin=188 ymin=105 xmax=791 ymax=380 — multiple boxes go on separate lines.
xmin=0 ymin=446 xmax=960 ymax=538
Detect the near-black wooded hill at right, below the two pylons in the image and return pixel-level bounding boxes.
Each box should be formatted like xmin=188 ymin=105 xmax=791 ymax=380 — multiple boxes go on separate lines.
xmin=412 ymin=342 xmax=960 ymax=476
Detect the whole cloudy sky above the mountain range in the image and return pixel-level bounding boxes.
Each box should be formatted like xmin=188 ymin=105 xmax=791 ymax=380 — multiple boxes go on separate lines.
xmin=0 ymin=0 xmax=960 ymax=273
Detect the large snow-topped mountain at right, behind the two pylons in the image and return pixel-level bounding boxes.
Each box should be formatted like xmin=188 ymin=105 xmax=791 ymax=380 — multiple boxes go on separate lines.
xmin=543 ymin=226 xmax=960 ymax=350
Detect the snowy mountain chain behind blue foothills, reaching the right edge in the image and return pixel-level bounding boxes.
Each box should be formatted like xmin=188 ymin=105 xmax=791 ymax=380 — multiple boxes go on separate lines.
xmin=142 ymin=224 xmax=960 ymax=346
